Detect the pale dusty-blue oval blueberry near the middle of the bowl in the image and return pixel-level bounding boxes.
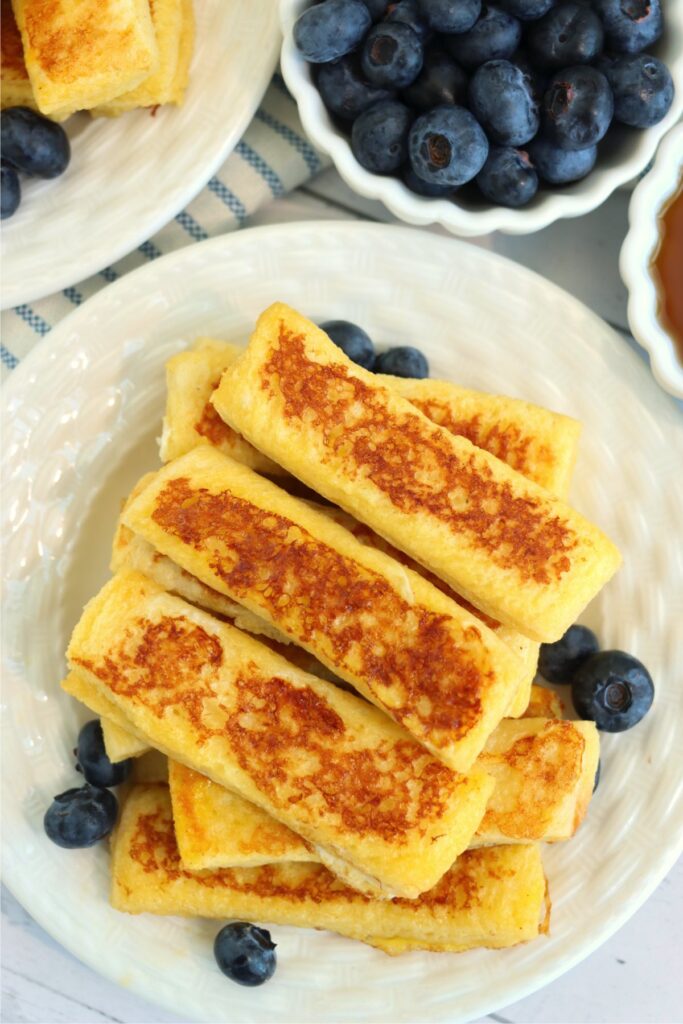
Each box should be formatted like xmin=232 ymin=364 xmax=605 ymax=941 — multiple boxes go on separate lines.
xmin=469 ymin=60 xmax=539 ymax=146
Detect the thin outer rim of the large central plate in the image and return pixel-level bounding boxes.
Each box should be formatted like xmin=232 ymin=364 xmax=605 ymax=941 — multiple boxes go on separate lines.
xmin=0 ymin=220 xmax=683 ymax=1024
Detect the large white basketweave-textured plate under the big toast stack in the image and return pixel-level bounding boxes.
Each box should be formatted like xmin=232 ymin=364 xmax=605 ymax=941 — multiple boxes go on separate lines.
xmin=2 ymin=223 xmax=683 ymax=1024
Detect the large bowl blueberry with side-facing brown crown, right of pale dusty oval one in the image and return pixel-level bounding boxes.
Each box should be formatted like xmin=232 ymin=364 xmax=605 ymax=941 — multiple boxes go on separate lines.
xmin=543 ymin=65 xmax=614 ymax=150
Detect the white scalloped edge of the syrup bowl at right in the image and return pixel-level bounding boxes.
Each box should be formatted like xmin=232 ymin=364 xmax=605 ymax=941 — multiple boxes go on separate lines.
xmin=620 ymin=124 xmax=683 ymax=398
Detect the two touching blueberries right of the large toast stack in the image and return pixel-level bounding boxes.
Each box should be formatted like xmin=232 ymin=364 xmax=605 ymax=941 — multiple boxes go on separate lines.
xmin=539 ymin=626 xmax=654 ymax=745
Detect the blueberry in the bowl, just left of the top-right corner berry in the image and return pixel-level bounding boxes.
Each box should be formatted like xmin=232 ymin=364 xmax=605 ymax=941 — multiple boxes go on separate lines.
xmin=526 ymin=0 xmax=604 ymax=69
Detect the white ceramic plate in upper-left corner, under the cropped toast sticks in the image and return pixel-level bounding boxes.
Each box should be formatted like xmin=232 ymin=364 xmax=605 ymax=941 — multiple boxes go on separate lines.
xmin=0 ymin=0 xmax=281 ymax=309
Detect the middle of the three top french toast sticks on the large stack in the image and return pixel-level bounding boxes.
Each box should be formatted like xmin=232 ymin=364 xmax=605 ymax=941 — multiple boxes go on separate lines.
xmin=123 ymin=447 xmax=524 ymax=771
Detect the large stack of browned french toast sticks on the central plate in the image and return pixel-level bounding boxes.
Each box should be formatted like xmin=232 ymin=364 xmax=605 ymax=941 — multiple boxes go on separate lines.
xmin=62 ymin=304 xmax=620 ymax=953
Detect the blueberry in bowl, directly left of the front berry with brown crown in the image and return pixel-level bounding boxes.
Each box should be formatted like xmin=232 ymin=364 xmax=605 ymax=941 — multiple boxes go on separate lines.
xmin=351 ymin=99 xmax=413 ymax=174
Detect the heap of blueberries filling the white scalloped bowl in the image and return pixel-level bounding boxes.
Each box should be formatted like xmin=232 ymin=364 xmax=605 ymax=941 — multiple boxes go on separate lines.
xmin=294 ymin=0 xmax=674 ymax=207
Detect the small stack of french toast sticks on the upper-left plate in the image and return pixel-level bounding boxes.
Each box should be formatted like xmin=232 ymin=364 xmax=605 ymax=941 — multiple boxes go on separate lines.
xmin=0 ymin=0 xmax=195 ymax=121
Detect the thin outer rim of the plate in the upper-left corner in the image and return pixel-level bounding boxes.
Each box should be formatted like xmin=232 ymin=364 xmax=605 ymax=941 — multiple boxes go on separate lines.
xmin=0 ymin=0 xmax=282 ymax=312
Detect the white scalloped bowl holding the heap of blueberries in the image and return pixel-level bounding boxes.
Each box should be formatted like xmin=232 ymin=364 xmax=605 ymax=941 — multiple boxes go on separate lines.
xmin=280 ymin=0 xmax=683 ymax=237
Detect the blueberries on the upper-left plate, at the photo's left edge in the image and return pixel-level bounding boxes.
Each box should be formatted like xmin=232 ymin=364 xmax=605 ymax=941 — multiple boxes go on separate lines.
xmin=0 ymin=106 xmax=71 ymax=220
